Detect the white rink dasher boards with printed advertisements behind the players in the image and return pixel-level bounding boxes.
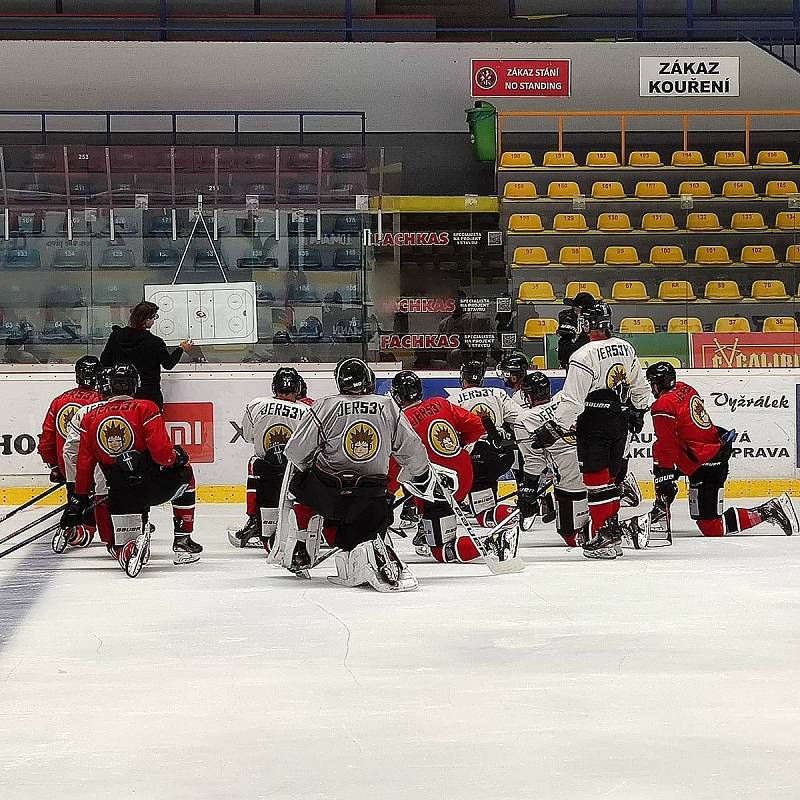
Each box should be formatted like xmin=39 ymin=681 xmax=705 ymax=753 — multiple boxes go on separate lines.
xmin=0 ymin=364 xmax=800 ymax=493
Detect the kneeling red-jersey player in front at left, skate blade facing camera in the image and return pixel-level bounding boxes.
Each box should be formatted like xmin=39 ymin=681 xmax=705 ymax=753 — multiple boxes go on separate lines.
xmin=61 ymin=364 xmax=203 ymax=578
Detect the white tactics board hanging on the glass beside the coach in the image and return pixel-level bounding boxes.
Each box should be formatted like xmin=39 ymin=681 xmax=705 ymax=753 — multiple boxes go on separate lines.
xmin=144 ymin=282 xmax=258 ymax=344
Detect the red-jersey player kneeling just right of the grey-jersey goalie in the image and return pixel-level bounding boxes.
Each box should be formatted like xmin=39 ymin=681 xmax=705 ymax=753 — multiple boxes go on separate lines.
xmin=390 ymin=371 xmax=486 ymax=562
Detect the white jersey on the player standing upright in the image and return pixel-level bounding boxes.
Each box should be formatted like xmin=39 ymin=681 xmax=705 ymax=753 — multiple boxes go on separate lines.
xmin=554 ymin=336 xmax=650 ymax=431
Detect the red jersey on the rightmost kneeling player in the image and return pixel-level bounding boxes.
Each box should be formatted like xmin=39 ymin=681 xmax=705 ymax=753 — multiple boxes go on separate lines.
xmin=650 ymin=381 xmax=722 ymax=475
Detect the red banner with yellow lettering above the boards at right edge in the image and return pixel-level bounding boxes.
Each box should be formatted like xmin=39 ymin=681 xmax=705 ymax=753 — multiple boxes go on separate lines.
xmin=692 ymin=333 xmax=800 ymax=369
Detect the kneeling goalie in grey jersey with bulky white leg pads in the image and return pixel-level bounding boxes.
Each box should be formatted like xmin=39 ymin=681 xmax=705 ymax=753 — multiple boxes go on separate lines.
xmin=273 ymin=358 xmax=435 ymax=592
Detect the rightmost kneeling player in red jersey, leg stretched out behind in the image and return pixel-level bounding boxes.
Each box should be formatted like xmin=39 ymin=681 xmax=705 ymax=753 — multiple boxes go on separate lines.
xmin=646 ymin=361 xmax=798 ymax=536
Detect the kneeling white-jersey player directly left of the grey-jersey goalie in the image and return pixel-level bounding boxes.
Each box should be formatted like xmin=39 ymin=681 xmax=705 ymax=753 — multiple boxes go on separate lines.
xmin=228 ymin=367 xmax=309 ymax=554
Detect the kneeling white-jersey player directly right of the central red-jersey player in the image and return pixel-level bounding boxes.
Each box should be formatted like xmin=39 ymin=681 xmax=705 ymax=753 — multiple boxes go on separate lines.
xmin=451 ymin=361 xmax=522 ymax=516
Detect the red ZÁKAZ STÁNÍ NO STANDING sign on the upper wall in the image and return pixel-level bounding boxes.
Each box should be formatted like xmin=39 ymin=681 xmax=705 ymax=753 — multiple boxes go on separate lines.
xmin=472 ymin=58 xmax=571 ymax=97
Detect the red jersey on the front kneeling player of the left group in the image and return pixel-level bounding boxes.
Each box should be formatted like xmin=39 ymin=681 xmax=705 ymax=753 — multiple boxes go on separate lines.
xmin=75 ymin=397 xmax=175 ymax=494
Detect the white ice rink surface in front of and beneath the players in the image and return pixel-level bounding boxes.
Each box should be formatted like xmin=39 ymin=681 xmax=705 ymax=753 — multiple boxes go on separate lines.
xmin=0 ymin=501 xmax=800 ymax=800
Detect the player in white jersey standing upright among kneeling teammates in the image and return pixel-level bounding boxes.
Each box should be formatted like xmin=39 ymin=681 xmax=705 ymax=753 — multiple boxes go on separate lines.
xmin=534 ymin=301 xmax=650 ymax=558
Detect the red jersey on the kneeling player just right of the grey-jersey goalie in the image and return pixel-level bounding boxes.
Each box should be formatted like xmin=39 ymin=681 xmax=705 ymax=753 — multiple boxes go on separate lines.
xmin=389 ymin=397 xmax=486 ymax=500
